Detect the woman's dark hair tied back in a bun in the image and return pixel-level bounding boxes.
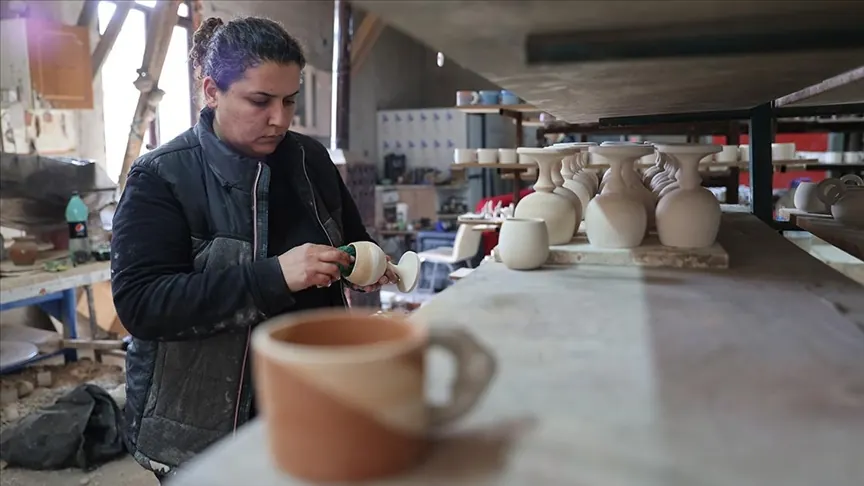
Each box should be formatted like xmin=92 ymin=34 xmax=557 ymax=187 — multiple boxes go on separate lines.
xmin=189 ymin=17 xmax=306 ymax=91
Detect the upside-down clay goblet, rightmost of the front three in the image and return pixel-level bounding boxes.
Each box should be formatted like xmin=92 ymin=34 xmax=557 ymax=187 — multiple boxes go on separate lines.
xmin=656 ymin=144 xmax=723 ymax=248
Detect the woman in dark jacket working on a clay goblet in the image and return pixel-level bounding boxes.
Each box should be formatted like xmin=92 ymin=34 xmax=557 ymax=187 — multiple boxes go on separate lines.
xmin=111 ymin=18 xmax=396 ymax=479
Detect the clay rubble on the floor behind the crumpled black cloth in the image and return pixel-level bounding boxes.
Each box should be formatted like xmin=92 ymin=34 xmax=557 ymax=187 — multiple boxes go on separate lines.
xmin=0 ymin=359 xmax=126 ymax=431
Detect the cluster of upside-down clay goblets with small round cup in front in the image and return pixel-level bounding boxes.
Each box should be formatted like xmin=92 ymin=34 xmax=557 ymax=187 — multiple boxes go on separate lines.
xmin=498 ymin=142 xmax=722 ymax=270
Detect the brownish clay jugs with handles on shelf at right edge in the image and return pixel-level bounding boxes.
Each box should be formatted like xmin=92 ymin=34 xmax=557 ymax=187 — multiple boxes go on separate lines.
xmin=794 ymin=174 xmax=864 ymax=226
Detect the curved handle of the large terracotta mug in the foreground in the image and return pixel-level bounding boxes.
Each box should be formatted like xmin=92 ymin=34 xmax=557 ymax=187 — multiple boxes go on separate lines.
xmin=429 ymin=329 xmax=497 ymax=427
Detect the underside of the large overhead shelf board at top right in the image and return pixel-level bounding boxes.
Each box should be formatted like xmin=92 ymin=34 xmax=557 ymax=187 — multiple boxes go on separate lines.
xmin=354 ymin=0 xmax=864 ymax=123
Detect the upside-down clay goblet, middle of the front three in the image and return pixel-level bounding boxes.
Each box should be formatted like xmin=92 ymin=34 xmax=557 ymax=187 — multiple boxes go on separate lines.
xmin=585 ymin=145 xmax=654 ymax=248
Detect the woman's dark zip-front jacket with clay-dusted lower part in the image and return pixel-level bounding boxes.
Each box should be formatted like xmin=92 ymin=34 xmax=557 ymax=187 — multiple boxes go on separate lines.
xmin=111 ymin=109 xmax=370 ymax=471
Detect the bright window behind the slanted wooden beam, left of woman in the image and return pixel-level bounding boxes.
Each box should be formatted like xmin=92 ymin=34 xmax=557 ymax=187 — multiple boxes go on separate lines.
xmin=98 ymin=0 xmax=194 ymax=181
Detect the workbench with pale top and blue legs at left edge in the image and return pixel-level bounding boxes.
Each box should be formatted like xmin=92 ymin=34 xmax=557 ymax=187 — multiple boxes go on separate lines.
xmin=0 ymin=262 xmax=111 ymax=374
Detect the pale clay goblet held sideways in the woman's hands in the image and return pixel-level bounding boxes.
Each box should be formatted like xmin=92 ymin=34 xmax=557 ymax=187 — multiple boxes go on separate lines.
xmin=345 ymin=241 xmax=420 ymax=292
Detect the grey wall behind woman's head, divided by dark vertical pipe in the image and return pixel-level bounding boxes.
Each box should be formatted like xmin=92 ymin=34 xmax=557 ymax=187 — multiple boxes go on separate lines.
xmin=204 ymin=0 xmax=495 ymax=165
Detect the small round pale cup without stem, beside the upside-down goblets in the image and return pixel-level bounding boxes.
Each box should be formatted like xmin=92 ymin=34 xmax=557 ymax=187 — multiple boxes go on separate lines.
xmin=498 ymin=218 xmax=549 ymax=270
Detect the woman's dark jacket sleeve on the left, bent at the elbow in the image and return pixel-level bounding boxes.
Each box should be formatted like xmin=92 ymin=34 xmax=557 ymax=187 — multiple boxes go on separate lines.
xmin=111 ymin=166 xmax=292 ymax=341
